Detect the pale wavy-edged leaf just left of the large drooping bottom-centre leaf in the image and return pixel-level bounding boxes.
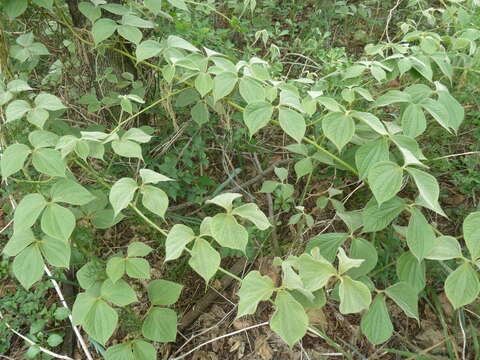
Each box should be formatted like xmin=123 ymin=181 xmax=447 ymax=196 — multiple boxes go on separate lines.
xmin=237 ymin=271 xmax=275 ymax=318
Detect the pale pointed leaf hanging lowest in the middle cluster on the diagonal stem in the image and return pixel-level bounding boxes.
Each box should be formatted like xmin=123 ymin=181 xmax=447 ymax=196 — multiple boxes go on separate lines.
xmin=188 ymin=238 xmax=220 ymax=283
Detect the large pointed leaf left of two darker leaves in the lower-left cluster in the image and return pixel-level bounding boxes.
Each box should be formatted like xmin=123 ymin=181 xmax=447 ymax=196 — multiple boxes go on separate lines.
xmin=82 ymin=298 xmax=118 ymax=345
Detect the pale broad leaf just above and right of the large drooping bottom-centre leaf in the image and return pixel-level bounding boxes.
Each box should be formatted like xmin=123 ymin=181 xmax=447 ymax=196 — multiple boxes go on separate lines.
xmin=298 ymin=254 xmax=337 ymax=292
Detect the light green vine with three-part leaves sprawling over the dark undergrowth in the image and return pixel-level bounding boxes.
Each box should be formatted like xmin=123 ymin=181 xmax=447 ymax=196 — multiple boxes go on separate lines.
xmin=0 ymin=0 xmax=480 ymax=360
